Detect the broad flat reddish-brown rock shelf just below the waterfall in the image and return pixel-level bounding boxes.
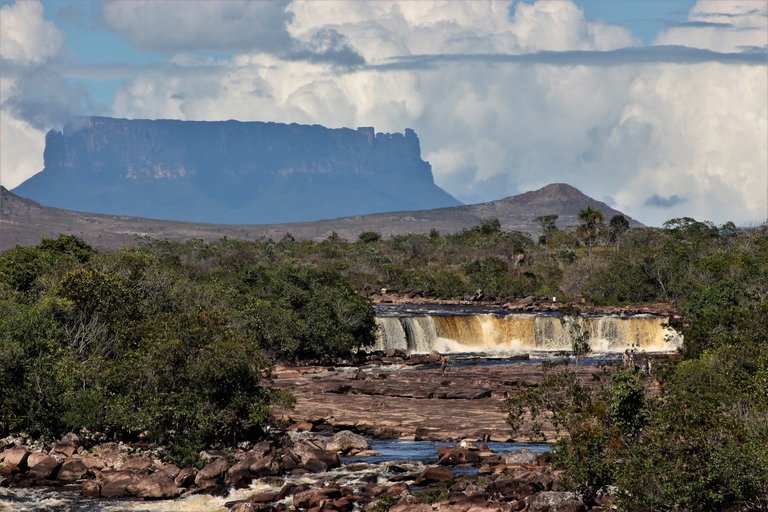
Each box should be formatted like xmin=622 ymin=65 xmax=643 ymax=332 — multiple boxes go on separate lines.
xmin=275 ymin=364 xmax=600 ymax=441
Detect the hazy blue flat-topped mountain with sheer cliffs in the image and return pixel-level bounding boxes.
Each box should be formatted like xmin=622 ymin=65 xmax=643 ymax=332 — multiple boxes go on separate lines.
xmin=14 ymin=117 xmax=461 ymax=224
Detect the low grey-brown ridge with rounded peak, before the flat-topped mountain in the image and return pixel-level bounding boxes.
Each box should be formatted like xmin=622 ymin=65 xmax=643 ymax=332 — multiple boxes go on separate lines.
xmin=0 ymin=183 xmax=643 ymax=251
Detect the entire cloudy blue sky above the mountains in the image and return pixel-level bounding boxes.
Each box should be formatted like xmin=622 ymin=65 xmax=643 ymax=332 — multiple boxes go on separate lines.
xmin=0 ymin=0 xmax=768 ymax=226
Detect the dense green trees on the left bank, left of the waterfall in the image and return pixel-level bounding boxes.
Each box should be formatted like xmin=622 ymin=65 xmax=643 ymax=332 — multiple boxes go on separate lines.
xmin=0 ymin=236 xmax=375 ymax=463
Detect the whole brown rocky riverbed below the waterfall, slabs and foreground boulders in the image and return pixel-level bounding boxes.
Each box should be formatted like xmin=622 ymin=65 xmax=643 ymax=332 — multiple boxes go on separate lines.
xmin=0 ymin=360 xmax=611 ymax=512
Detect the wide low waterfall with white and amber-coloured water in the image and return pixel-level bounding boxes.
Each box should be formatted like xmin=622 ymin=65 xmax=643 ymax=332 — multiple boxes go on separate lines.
xmin=376 ymin=313 xmax=682 ymax=354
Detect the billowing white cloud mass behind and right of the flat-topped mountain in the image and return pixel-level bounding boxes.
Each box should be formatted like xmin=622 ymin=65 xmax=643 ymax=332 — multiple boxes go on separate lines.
xmin=103 ymin=1 xmax=768 ymax=225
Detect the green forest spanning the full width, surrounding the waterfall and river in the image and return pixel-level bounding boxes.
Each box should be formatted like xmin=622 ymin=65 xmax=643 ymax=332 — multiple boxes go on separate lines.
xmin=0 ymin=213 xmax=768 ymax=510
